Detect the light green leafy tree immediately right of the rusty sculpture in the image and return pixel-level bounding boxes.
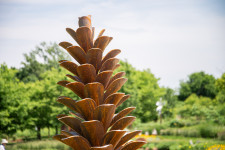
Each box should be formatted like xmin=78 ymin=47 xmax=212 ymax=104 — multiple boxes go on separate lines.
xmin=118 ymin=61 xmax=164 ymax=122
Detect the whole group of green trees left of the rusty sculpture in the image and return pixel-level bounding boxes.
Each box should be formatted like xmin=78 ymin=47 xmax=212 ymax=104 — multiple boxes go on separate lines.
xmin=0 ymin=42 xmax=73 ymax=138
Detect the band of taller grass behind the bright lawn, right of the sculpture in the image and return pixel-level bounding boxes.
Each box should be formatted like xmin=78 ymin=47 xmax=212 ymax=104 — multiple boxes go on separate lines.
xmin=136 ymin=120 xmax=225 ymax=140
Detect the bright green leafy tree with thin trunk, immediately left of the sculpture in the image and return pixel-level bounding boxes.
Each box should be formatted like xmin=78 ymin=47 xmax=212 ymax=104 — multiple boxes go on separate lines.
xmin=27 ymin=68 xmax=77 ymax=139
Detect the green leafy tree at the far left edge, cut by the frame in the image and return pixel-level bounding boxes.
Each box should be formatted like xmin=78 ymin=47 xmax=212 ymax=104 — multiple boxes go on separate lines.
xmin=0 ymin=64 xmax=29 ymax=135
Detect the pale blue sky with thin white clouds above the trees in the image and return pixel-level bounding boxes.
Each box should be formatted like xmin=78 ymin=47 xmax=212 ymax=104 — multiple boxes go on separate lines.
xmin=0 ymin=0 xmax=225 ymax=89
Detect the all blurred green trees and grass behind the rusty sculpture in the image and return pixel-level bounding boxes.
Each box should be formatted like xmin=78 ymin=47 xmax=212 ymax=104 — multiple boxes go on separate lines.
xmin=0 ymin=42 xmax=225 ymax=149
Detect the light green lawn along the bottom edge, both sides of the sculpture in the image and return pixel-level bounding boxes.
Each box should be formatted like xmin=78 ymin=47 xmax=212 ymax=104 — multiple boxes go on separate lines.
xmin=6 ymin=135 xmax=225 ymax=150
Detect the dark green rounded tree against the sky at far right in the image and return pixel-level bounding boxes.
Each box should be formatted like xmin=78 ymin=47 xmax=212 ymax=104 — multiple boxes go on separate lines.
xmin=178 ymin=72 xmax=217 ymax=100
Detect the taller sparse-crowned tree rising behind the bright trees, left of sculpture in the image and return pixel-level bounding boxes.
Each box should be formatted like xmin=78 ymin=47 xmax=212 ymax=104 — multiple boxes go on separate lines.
xmin=16 ymin=42 xmax=70 ymax=83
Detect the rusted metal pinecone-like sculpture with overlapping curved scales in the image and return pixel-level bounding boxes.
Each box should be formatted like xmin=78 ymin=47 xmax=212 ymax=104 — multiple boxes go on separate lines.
xmin=54 ymin=16 xmax=145 ymax=150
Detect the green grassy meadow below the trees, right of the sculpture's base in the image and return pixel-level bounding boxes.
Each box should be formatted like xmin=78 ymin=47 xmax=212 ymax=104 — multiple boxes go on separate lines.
xmin=134 ymin=119 xmax=225 ymax=150
